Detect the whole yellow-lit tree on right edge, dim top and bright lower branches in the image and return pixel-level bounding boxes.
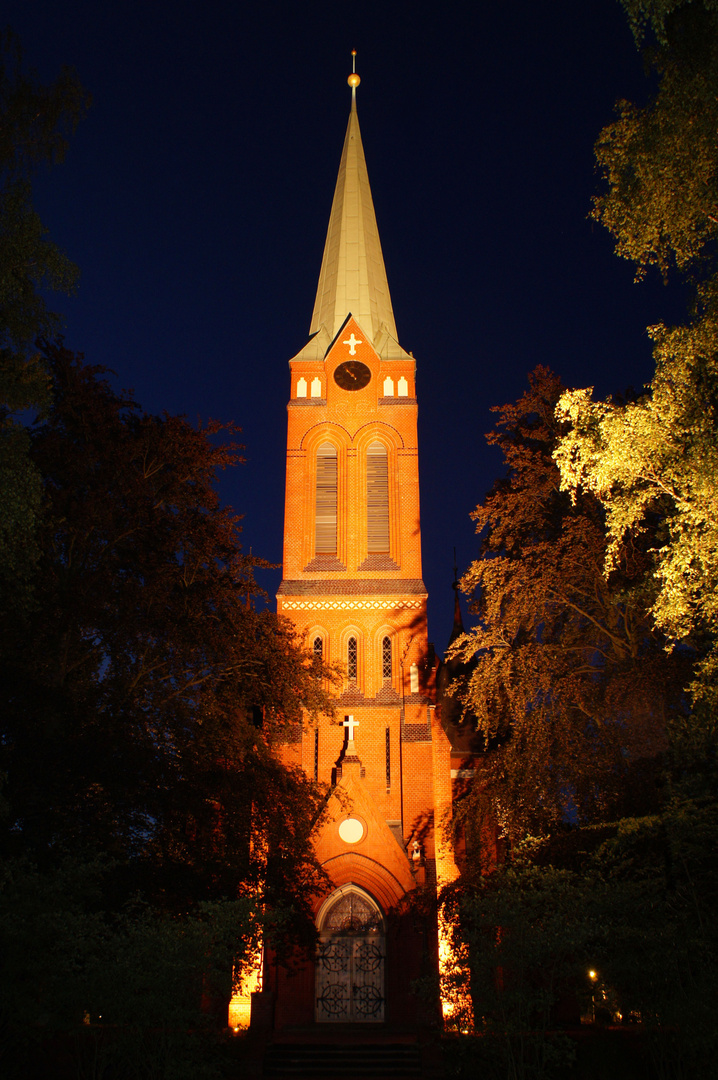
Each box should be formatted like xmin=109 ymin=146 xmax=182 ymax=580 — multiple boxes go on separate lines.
xmin=556 ymin=0 xmax=718 ymax=701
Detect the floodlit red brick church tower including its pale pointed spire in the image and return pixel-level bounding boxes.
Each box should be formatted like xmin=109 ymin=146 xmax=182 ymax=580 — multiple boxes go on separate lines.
xmin=265 ymin=56 xmax=450 ymax=1027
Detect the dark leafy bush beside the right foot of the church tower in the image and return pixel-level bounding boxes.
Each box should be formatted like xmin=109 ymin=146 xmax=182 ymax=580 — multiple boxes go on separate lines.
xmin=441 ymin=859 xmax=594 ymax=1080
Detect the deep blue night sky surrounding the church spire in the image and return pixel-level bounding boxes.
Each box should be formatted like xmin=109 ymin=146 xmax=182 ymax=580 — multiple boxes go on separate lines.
xmin=2 ymin=0 xmax=679 ymax=649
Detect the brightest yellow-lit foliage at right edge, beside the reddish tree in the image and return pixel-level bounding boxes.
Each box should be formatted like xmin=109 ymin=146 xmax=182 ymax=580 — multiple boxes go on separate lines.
xmin=556 ymin=318 xmax=718 ymax=697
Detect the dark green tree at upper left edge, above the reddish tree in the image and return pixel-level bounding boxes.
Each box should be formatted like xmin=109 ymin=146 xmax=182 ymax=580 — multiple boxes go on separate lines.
xmin=0 ymin=29 xmax=90 ymax=603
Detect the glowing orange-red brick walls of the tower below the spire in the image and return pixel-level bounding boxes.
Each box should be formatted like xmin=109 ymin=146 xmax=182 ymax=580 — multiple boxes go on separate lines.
xmin=265 ymin=316 xmax=450 ymax=1027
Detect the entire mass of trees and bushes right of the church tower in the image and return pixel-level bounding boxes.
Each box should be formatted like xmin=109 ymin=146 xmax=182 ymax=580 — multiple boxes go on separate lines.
xmin=445 ymin=12 xmax=718 ymax=1078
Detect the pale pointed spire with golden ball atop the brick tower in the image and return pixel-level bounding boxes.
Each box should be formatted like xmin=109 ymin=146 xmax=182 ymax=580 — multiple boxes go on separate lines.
xmin=310 ymin=52 xmax=396 ymax=347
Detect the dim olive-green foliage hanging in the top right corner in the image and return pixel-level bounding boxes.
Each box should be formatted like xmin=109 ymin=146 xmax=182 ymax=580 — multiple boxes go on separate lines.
xmin=593 ymin=0 xmax=718 ymax=281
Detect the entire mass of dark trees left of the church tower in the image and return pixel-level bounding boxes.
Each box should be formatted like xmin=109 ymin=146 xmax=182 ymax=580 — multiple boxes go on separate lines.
xmin=0 ymin=38 xmax=341 ymax=1078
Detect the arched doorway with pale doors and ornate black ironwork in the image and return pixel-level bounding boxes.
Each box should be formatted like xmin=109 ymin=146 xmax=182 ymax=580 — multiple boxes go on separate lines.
xmin=315 ymin=885 xmax=387 ymax=1024
